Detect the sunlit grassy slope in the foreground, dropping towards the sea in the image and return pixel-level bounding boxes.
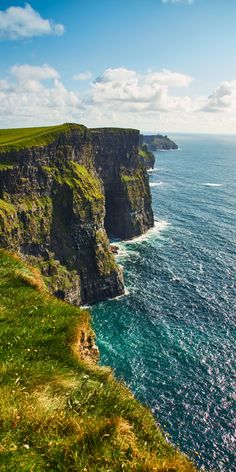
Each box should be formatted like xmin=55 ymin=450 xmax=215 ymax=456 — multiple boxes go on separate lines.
xmin=0 ymin=251 xmax=194 ymax=472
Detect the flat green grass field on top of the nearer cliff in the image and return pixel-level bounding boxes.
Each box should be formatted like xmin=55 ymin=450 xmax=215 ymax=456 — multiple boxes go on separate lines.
xmin=0 ymin=123 xmax=85 ymax=153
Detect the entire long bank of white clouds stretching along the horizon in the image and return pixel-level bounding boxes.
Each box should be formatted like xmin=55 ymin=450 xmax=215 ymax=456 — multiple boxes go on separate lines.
xmin=0 ymin=64 xmax=236 ymax=133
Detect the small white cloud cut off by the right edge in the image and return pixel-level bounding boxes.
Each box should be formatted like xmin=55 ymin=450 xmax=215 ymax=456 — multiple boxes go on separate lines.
xmin=202 ymin=80 xmax=236 ymax=113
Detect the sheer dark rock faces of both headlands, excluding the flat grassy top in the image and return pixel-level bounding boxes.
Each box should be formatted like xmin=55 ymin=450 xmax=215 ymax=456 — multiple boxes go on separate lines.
xmin=0 ymin=126 xmax=152 ymax=304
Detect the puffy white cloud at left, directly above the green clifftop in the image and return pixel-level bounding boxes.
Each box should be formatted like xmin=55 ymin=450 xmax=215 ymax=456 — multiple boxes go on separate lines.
xmin=0 ymin=64 xmax=79 ymax=126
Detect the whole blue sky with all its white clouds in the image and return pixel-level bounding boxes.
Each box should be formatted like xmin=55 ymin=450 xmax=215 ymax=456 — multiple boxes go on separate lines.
xmin=0 ymin=0 xmax=236 ymax=134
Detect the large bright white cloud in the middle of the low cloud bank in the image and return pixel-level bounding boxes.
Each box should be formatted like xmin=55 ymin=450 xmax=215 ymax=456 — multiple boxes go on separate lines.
xmin=86 ymin=68 xmax=193 ymax=112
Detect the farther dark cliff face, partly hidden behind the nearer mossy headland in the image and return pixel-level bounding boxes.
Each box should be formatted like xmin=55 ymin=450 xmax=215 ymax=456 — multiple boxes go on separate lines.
xmin=91 ymin=128 xmax=153 ymax=239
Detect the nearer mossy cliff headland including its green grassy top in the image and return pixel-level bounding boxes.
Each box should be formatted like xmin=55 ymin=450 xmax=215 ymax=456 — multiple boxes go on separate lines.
xmin=0 ymin=124 xmax=124 ymax=305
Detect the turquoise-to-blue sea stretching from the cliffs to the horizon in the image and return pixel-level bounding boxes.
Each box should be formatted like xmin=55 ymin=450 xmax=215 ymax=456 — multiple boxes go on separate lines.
xmin=93 ymin=135 xmax=236 ymax=471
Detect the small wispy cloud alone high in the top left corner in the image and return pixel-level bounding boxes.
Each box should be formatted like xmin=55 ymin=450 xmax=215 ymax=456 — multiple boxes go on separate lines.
xmin=0 ymin=3 xmax=64 ymax=39
